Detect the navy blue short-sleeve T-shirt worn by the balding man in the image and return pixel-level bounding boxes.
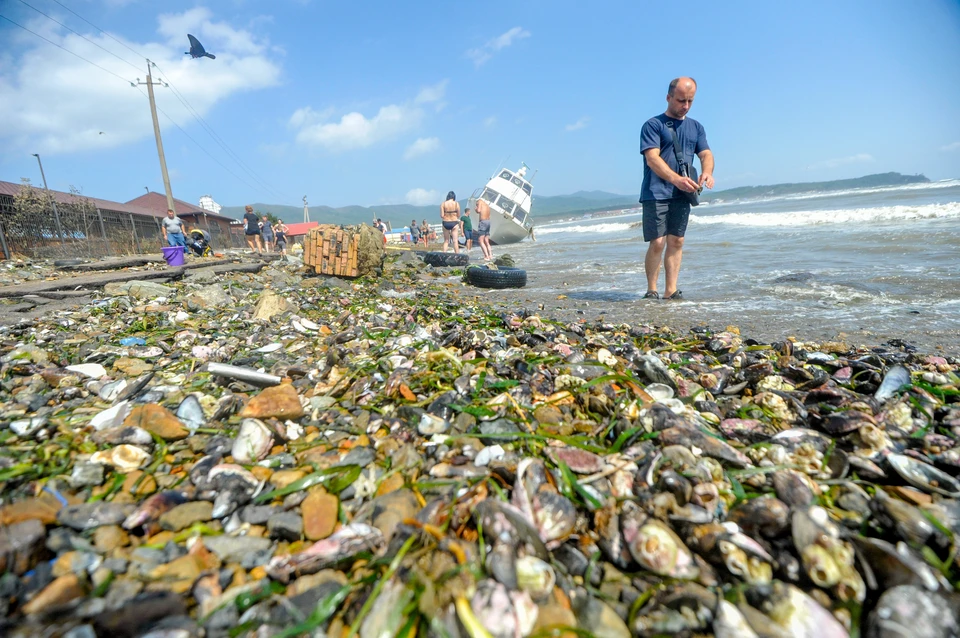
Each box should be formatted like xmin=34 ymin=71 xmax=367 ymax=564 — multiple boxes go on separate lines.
xmin=640 ymin=113 xmax=710 ymax=202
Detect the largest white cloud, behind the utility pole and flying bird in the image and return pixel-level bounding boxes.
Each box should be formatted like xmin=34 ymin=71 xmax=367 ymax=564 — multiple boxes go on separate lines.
xmin=0 ymin=9 xmax=280 ymax=154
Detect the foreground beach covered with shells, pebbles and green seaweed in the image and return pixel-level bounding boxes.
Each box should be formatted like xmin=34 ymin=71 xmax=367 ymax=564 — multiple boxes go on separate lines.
xmin=0 ymin=251 xmax=960 ymax=638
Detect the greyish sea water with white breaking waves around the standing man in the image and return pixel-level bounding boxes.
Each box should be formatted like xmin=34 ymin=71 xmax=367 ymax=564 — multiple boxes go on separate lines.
xmin=474 ymin=180 xmax=960 ymax=354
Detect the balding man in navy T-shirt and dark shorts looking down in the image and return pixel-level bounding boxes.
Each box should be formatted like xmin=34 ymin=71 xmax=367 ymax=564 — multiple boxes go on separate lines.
xmin=640 ymin=77 xmax=713 ymax=300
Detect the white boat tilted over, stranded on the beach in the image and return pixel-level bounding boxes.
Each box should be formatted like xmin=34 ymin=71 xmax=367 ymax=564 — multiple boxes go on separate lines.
xmin=468 ymin=165 xmax=533 ymax=244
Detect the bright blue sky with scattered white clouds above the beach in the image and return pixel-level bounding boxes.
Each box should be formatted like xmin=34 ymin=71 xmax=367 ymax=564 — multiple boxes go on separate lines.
xmin=0 ymin=0 xmax=960 ymax=206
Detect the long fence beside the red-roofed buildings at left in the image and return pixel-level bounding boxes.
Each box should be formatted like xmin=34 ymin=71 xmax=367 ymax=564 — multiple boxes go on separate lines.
xmin=0 ymin=189 xmax=244 ymax=259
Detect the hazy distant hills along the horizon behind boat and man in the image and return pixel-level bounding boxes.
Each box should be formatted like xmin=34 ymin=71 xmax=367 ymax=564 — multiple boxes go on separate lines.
xmin=220 ymin=173 xmax=930 ymax=228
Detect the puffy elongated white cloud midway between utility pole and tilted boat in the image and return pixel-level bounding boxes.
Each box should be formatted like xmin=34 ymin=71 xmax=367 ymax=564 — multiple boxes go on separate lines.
xmin=290 ymin=104 xmax=423 ymax=151
